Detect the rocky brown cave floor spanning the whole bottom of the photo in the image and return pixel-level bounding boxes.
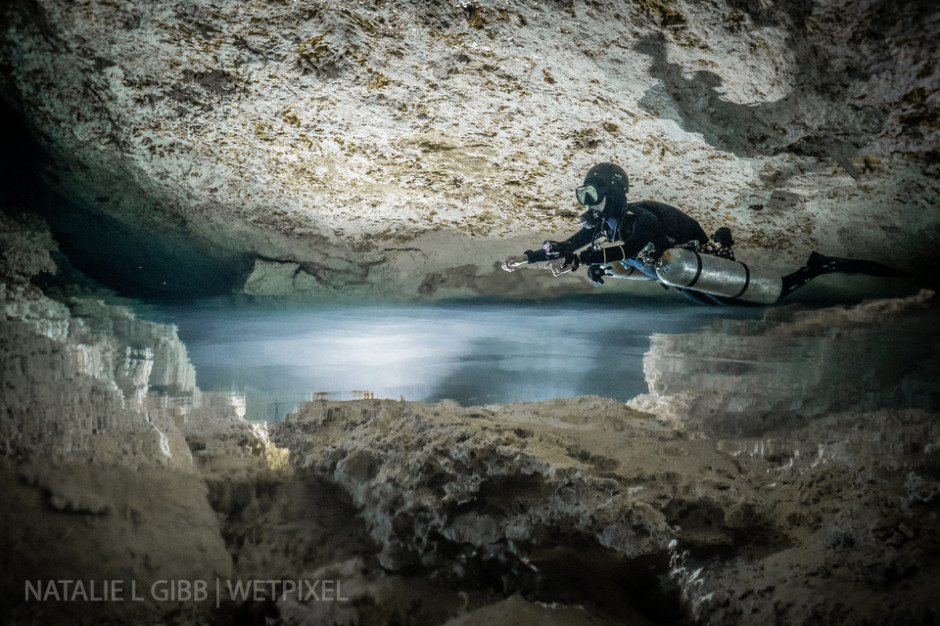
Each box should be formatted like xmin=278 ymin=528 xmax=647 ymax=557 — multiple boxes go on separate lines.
xmin=2 ymin=390 xmax=940 ymax=624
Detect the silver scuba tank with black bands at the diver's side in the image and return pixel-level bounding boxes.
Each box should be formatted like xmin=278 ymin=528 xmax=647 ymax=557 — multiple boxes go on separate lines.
xmin=655 ymin=248 xmax=783 ymax=304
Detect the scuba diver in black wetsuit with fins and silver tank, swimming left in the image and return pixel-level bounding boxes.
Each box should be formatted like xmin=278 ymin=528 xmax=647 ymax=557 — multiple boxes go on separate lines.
xmin=502 ymin=163 xmax=905 ymax=304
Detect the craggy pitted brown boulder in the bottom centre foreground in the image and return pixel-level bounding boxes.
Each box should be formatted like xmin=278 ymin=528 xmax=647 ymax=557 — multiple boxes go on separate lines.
xmin=272 ymin=397 xmax=749 ymax=585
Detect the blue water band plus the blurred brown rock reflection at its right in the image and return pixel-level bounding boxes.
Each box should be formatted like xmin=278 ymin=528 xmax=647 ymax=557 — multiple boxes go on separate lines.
xmin=145 ymin=284 xmax=940 ymax=422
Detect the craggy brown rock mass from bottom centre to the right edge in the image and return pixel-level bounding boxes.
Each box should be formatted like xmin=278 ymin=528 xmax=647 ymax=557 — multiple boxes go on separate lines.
xmin=274 ymin=398 xmax=940 ymax=624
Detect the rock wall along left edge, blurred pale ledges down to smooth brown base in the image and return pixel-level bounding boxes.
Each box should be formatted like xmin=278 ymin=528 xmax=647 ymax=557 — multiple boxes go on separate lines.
xmin=0 ymin=208 xmax=262 ymax=624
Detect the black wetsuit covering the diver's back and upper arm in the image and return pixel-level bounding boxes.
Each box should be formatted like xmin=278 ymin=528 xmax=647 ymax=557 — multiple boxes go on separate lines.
xmin=525 ymin=199 xmax=708 ymax=265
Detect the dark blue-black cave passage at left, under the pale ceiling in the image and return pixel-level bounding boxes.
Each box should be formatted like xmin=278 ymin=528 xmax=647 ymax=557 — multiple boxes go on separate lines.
xmin=0 ymin=101 xmax=251 ymax=300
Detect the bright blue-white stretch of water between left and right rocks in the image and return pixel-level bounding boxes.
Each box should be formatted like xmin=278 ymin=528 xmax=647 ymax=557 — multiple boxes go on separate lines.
xmin=149 ymin=299 xmax=760 ymax=421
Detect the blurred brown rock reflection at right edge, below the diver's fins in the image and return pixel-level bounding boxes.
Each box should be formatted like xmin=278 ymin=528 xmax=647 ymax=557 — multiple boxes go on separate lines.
xmin=631 ymin=292 xmax=940 ymax=439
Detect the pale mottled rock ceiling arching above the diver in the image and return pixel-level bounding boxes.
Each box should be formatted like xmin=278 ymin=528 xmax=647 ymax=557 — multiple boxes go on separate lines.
xmin=0 ymin=0 xmax=940 ymax=298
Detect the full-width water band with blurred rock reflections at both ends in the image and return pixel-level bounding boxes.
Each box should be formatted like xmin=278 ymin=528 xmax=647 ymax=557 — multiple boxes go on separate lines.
xmin=0 ymin=292 xmax=940 ymax=454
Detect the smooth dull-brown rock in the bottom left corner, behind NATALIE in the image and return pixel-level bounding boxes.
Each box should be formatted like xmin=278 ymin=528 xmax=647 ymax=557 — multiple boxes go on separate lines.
xmin=0 ymin=459 xmax=232 ymax=624
